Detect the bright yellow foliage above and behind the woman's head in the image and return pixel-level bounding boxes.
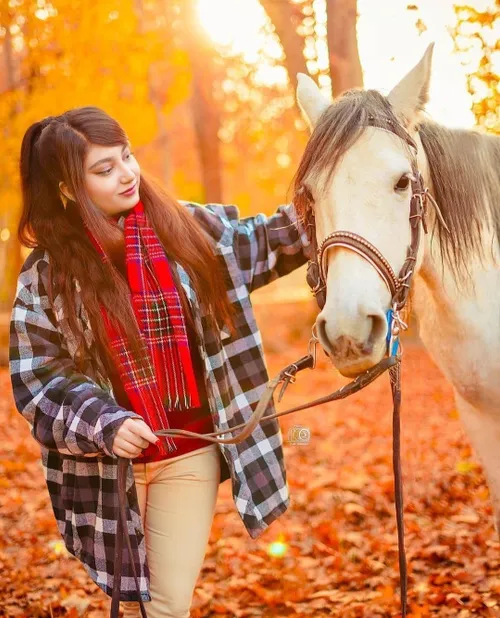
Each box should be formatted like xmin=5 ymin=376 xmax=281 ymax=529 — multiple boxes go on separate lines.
xmin=0 ymin=0 xmax=192 ymax=212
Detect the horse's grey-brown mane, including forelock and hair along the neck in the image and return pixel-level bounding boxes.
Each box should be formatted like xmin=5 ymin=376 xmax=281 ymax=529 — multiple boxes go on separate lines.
xmin=293 ymin=90 xmax=500 ymax=279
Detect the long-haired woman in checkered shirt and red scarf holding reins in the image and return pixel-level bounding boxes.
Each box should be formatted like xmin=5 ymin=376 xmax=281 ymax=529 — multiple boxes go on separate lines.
xmin=10 ymin=107 xmax=308 ymax=618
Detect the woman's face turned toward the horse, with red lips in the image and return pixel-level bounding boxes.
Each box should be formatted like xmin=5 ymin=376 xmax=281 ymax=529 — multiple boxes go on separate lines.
xmin=84 ymin=145 xmax=141 ymax=216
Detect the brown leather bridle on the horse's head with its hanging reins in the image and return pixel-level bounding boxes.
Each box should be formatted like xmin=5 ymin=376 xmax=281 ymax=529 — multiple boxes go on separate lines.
xmin=110 ymin=117 xmax=446 ymax=618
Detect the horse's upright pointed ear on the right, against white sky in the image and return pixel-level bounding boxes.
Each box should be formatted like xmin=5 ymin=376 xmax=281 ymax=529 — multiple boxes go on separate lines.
xmin=387 ymin=43 xmax=434 ymax=127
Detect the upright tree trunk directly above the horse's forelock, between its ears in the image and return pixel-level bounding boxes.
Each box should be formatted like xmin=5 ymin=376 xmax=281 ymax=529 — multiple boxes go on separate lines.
xmin=326 ymin=0 xmax=363 ymax=97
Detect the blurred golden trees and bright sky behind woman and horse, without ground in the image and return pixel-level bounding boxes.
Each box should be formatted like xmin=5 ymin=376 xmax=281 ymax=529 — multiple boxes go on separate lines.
xmin=0 ymin=0 xmax=500 ymax=356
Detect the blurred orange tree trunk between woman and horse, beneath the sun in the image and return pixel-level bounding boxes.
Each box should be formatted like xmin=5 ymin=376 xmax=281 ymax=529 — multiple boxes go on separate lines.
xmin=183 ymin=0 xmax=223 ymax=203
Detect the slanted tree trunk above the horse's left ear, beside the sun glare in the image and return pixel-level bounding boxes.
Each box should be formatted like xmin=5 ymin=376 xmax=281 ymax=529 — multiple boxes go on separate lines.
xmin=260 ymin=0 xmax=309 ymax=90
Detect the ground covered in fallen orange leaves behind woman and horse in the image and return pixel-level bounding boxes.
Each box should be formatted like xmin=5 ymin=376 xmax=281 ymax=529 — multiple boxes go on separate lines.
xmin=0 ymin=304 xmax=500 ymax=618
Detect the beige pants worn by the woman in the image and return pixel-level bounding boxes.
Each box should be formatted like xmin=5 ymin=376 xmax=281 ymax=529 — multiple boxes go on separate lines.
xmin=120 ymin=444 xmax=220 ymax=618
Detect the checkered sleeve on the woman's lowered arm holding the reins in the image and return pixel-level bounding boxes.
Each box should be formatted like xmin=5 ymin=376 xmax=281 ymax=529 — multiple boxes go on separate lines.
xmin=9 ymin=276 xmax=140 ymax=456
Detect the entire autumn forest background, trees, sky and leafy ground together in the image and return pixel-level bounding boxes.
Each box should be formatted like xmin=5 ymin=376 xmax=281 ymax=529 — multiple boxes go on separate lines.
xmin=0 ymin=0 xmax=500 ymax=618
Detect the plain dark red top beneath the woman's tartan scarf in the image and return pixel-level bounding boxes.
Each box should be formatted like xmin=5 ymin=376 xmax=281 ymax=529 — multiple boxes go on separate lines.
xmin=111 ymin=323 xmax=214 ymax=463
